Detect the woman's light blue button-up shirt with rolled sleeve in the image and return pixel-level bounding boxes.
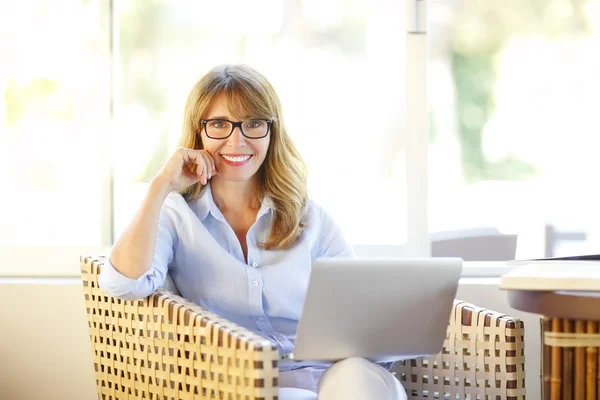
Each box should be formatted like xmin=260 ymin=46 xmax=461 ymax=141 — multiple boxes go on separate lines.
xmin=99 ymin=184 xmax=354 ymax=354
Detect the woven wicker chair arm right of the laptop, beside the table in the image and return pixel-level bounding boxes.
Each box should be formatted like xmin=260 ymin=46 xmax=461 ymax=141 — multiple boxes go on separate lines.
xmin=395 ymin=301 xmax=525 ymax=400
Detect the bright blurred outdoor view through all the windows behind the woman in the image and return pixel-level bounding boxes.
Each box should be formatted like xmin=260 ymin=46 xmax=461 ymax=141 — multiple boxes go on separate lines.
xmin=0 ymin=0 xmax=600 ymax=268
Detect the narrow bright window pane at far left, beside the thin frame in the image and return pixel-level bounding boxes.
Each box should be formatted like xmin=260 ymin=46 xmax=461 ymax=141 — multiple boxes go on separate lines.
xmin=0 ymin=0 xmax=109 ymax=246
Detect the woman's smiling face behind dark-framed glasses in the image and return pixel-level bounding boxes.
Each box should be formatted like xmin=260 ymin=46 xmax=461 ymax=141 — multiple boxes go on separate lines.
xmin=201 ymin=96 xmax=271 ymax=182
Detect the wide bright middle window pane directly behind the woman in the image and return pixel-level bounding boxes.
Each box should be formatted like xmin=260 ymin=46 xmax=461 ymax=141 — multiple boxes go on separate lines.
xmin=115 ymin=0 xmax=406 ymax=245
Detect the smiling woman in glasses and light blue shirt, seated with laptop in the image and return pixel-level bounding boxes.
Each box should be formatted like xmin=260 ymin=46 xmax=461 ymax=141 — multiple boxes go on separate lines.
xmin=99 ymin=65 xmax=406 ymax=400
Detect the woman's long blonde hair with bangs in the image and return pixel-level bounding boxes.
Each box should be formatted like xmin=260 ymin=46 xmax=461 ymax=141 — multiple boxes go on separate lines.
xmin=179 ymin=64 xmax=308 ymax=250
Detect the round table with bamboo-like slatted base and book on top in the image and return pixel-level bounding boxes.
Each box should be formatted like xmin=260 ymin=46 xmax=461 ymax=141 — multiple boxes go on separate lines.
xmin=500 ymin=260 xmax=600 ymax=400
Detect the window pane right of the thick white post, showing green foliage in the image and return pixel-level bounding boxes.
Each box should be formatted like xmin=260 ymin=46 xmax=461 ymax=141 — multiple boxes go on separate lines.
xmin=430 ymin=0 xmax=600 ymax=257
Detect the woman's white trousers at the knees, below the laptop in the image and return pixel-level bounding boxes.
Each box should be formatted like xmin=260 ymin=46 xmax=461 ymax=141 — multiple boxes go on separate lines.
xmin=279 ymin=357 xmax=407 ymax=400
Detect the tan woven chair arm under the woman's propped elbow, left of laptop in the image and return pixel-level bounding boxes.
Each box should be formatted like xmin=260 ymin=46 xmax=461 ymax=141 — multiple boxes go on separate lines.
xmin=80 ymin=257 xmax=279 ymax=400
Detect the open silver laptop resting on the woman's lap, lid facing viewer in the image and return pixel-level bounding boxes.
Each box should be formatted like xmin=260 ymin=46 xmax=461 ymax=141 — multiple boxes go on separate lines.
xmin=280 ymin=258 xmax=462 ymax=367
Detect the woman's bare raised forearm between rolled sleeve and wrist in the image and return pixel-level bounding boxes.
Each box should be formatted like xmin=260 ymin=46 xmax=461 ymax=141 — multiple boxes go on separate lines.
xmin=110 ymin=178 xmax=170 ymax=279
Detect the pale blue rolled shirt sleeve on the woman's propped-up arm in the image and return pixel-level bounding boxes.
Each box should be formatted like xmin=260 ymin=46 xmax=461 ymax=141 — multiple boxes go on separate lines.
xmin=98 ymin=212 xmax=177 ymax=300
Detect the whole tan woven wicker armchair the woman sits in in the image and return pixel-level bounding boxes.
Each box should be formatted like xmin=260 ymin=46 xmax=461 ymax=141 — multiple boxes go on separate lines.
xmin=81 ymin=257 xmax=525 ymax=400
